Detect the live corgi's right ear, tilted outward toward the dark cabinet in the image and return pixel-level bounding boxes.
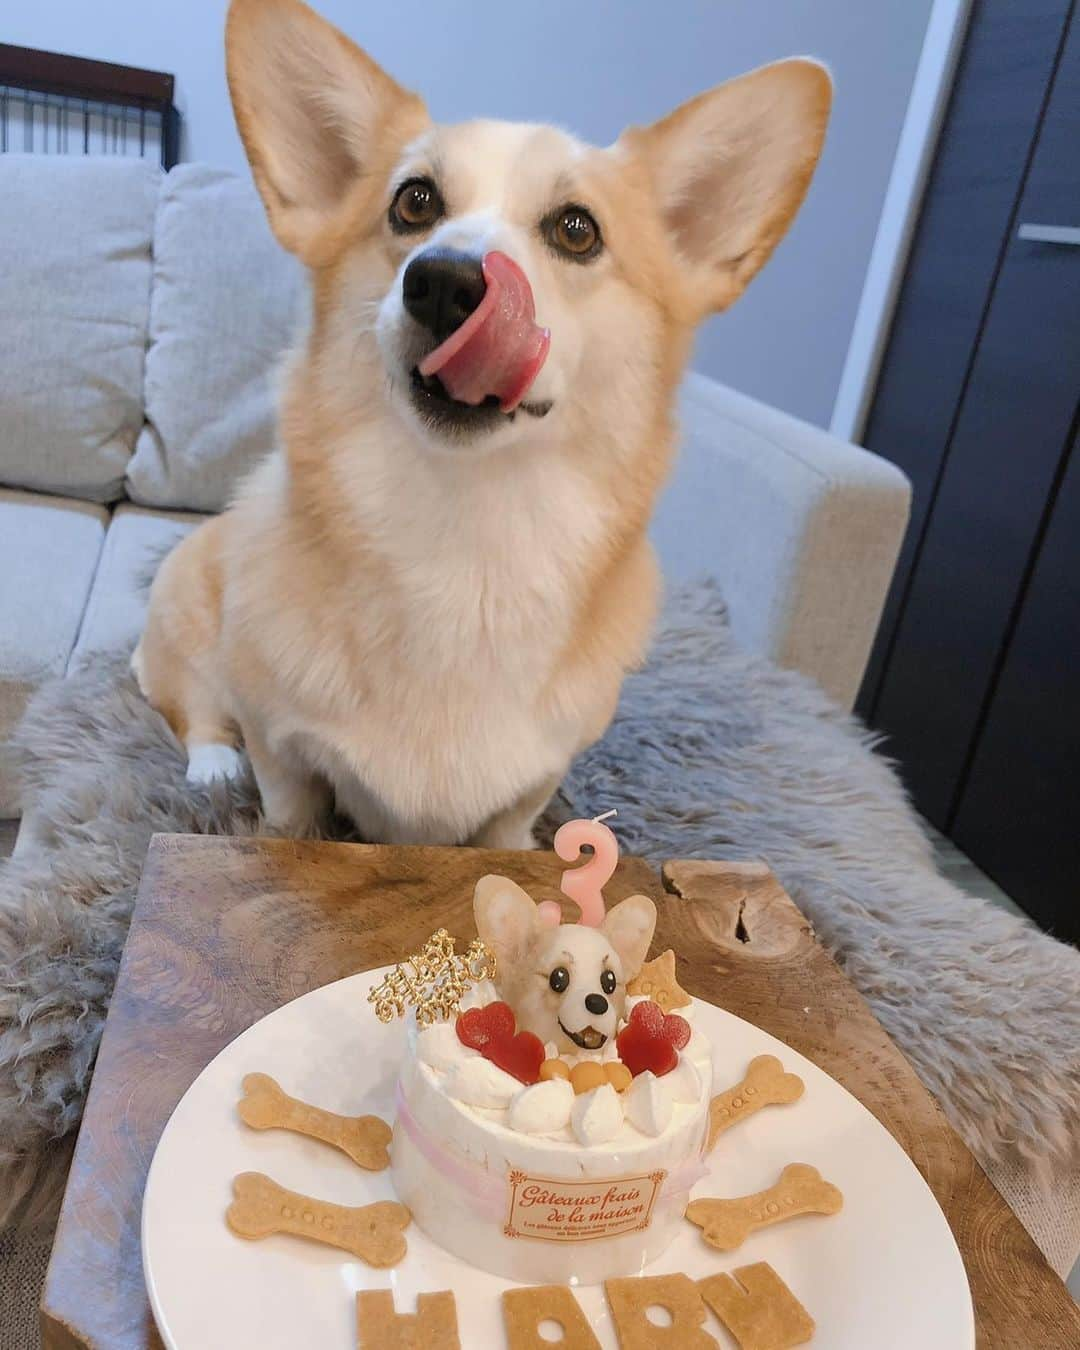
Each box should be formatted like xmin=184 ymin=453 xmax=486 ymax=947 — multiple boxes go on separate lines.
xmin=621 ymin=59 xmax=833 ymax=317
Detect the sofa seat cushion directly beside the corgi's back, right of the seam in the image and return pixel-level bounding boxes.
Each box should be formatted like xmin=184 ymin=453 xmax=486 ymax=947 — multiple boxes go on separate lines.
xmin=68 ymin=502 xmax=205 ymax=671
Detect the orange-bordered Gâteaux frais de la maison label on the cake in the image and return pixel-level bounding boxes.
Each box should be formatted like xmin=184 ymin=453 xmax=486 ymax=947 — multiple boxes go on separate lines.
xmin=502 ymin=1170 xmax=667 ymax=1242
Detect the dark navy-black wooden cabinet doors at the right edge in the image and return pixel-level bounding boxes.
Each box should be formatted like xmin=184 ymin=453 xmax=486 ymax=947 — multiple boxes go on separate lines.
xmin=860 ymin=0 xmax=1080 ymax=940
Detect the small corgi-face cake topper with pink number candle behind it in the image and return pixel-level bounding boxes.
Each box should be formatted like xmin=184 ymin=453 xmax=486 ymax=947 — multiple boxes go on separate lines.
xmin=473 ymin=821 xmax=656 ymax=1054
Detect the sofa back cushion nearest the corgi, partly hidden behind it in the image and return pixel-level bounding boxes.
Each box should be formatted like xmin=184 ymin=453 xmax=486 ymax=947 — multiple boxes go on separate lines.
xmin=127 ymin=165 xmax=306 ymax=510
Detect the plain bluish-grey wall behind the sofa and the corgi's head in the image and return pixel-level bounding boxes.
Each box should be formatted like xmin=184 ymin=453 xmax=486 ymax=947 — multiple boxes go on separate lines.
xmin=0 ymin=0 xmax=930 ymax=425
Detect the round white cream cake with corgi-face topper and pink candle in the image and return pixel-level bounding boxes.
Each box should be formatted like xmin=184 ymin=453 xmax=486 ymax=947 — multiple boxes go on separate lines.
xmin=390 ymin=821 xmax=713 ymax=1284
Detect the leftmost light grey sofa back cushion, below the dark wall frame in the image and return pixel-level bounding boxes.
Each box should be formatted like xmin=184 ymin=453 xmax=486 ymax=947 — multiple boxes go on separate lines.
xmin=0 ymin=154 xmax=162 ymax=501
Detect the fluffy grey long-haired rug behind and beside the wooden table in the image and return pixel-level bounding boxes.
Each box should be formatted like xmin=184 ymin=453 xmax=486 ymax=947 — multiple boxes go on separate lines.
xmin=0 ymin=586 xmax=1080 ymax=1268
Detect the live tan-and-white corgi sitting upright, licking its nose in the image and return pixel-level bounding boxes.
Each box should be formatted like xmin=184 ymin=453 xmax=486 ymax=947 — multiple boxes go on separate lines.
xmin=132 ymin=0 xmax=832 ymax=848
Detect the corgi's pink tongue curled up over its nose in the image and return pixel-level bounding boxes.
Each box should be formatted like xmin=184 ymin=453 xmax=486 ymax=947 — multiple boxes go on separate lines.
xmin=420 ymin=252 xmax=551 ymax=413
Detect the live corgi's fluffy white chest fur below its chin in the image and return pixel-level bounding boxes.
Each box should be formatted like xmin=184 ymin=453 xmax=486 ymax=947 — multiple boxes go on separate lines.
xmin=274 ymin=442 xmax=605 ymax=842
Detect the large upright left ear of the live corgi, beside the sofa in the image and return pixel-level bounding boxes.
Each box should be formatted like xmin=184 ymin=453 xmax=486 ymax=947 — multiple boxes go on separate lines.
xmin=225 ymin=0 xmax=427 ymax=262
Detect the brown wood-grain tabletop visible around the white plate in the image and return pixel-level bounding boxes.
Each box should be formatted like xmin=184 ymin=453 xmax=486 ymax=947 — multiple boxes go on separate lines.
xmin=42 ymin=836 xmax=1080 ymax=1350
